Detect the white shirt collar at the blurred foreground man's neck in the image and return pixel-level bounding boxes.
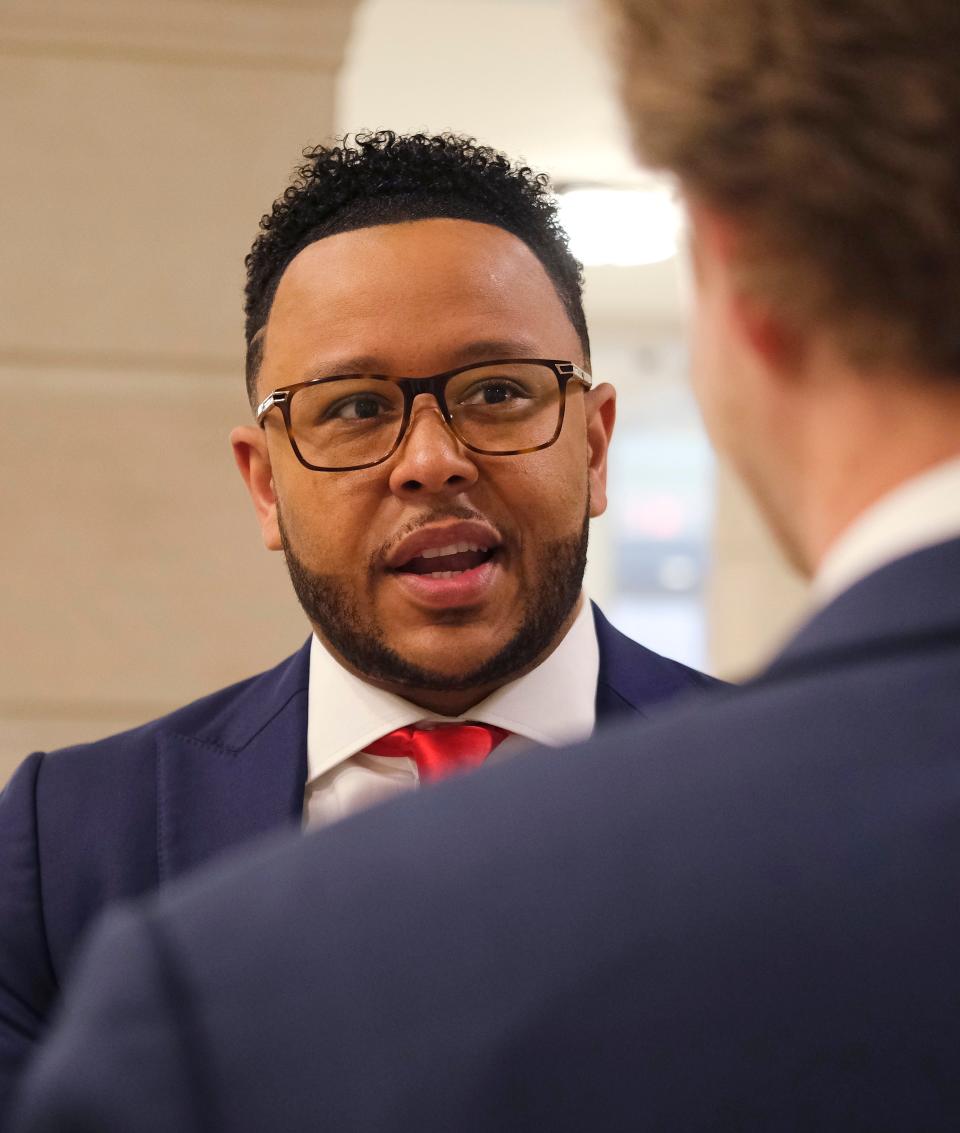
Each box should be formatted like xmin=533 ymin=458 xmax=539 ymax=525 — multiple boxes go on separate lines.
xmin=810 ymin=458 xmax=960 ymax=606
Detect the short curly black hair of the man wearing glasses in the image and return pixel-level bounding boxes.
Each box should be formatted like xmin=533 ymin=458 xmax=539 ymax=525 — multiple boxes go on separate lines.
xmin=245 ymin=130 xmax=589 ymax=402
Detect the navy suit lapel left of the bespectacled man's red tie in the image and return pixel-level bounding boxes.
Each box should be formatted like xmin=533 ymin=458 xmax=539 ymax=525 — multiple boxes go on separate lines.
xmin=156 ymin=641 xmax=309 ymax=883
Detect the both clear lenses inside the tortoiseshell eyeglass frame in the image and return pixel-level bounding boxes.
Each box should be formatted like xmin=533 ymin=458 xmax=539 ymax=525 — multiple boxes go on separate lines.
xmin=290 ymin=363 xmax=560 ymax=468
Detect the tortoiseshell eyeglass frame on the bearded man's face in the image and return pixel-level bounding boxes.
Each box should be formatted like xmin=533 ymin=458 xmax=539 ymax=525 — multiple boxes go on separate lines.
xmin=255 ymin=358 xmax=593 ymax=472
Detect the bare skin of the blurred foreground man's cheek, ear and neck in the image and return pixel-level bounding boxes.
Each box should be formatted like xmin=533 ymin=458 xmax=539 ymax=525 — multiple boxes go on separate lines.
xmin=688 ymin=197 xmax=960 ymax=578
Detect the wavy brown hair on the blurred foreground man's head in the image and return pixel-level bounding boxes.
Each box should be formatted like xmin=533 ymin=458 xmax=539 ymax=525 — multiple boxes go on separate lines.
xmin=609 ymin=0 xmax=960 ymax=381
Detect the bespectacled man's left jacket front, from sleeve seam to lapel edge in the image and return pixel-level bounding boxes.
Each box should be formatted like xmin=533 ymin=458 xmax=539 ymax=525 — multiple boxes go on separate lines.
xmin=31 ymin=645 xmax=309 ymax=969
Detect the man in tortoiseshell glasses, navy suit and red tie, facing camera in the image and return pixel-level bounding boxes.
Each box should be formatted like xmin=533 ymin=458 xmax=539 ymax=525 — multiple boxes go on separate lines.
xmin=0 ymin=134 xmax=712 ymax=1123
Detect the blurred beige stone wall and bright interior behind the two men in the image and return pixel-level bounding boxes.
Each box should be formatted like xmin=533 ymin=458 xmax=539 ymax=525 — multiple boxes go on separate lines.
xmin=0 ymin=0 xmax=804 ymax=782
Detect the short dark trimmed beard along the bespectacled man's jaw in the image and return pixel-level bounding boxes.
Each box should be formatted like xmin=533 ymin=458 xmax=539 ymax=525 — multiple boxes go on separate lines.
xmin=277 ymin=500 xmax=589 ymax=692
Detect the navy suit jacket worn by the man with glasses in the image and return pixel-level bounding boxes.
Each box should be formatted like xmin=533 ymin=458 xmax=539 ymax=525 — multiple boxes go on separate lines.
xmin=0 ymin=607 xmax=717 ymax=1124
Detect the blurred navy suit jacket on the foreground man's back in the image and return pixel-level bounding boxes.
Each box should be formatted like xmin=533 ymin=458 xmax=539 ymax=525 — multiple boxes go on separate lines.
xmin=15 ymin=540 xmax=960 ymax=1133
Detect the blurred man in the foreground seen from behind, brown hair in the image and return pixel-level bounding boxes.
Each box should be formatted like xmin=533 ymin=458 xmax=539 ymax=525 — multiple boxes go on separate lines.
xmin=18 ymin=0 xmax=960 ymax=1133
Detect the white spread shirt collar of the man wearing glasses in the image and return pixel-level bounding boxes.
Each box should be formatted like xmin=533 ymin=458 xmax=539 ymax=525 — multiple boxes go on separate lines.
xmin=307 ymin=596 xmax=600 ymax=783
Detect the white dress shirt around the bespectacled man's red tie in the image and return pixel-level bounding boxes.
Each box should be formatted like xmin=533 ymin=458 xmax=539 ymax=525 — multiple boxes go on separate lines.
xmin=304 ymin=596 xmax=600 ymax=828
